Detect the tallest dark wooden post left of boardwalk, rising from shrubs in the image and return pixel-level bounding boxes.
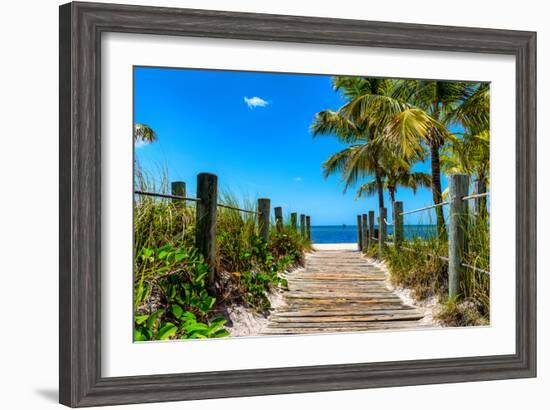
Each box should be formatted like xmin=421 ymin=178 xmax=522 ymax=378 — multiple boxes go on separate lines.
xmin=195 ymin=173 xmax=218 ymax=286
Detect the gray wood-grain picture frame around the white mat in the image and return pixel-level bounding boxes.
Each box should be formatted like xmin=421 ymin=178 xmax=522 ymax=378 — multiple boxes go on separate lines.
xmin=59 ymin=3 xmax=536 ymax=407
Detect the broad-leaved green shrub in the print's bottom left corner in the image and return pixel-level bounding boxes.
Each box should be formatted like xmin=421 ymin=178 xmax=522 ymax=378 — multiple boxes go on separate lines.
xmin=134 ymin=245 xmax=227 ymax=341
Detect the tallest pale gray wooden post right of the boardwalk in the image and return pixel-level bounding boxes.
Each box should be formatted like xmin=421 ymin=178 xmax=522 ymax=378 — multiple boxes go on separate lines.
xmin=449 ymin=174 xmax=469 ymax=297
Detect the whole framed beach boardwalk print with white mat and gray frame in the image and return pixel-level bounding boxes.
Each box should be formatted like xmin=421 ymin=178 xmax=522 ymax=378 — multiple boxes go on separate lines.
xmin=60 ymin=3 xmax=536 ymax=407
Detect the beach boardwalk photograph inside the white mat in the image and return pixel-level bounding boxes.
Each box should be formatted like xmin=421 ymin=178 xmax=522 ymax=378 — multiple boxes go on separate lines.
xmin=133 ymin=66 xmax=491 ymax=343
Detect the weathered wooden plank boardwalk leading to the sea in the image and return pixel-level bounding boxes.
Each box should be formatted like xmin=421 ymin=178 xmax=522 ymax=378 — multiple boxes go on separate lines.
xmin=263 ymin=250 xmax=423 ymax=335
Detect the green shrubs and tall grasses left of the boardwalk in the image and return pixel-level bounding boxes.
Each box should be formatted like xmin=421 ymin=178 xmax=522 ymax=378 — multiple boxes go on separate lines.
xmin=134 ymin=164 xmax=310 ymax=341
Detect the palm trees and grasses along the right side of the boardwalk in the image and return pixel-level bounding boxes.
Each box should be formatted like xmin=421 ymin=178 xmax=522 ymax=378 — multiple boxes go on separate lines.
xmin=311 ymin=77 xmax=490 ymax=325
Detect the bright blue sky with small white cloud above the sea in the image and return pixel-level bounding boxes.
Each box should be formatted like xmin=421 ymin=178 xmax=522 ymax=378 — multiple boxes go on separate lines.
xmin=134 ymin=67 xmax=447 ymax=225
